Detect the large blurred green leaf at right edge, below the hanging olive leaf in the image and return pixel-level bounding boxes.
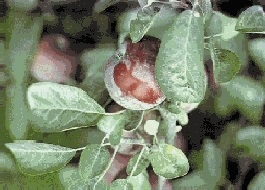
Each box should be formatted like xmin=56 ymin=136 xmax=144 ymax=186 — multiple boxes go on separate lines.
xmin=215 ymin=76 xmax=265 ymax=122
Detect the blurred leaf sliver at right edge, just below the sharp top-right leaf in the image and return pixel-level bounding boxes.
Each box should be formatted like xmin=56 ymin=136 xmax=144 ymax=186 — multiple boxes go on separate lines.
xmin=248 ymin=38 xmax=265 ymax=72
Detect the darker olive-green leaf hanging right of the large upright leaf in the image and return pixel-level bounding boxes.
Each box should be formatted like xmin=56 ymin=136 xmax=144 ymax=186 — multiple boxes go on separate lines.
xmin=210 ymin=42 xmax=240 ymax=83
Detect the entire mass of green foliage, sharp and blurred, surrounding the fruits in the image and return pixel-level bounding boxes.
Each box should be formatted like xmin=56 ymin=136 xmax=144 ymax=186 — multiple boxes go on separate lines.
xmin=0 ymin=0 xmax=265 ymax=190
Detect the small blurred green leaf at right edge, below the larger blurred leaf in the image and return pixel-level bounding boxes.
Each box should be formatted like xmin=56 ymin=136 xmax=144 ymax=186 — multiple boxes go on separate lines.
xmin=235 ymin=126 xmax=265 ymax=159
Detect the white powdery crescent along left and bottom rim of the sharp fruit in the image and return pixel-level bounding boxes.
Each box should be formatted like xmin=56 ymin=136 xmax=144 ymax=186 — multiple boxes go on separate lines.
xmin=104 ymin=55 xmax=165 ymax=110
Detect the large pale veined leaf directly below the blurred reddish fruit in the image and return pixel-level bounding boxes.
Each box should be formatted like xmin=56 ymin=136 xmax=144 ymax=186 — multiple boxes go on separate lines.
xmin=27 ymin=82 xmax=104 ymax=132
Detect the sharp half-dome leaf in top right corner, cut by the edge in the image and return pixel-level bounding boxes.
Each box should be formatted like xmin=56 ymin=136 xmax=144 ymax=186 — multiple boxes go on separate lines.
xmin=235 ymin=5 xmax=265 ymax=34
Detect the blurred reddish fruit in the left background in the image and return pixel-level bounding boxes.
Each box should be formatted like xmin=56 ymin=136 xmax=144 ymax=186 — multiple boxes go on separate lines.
xmin=31 ymin=34 xmax=78 ymax=83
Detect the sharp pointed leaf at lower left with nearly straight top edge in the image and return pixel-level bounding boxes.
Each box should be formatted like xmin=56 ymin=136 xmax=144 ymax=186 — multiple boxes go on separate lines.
xmin=5 ymin=143 xmax=76 ymax=175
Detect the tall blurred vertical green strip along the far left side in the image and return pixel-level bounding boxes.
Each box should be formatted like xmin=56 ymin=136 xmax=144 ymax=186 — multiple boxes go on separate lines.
xmin=4 ymin=11 xmax=43 ymax=139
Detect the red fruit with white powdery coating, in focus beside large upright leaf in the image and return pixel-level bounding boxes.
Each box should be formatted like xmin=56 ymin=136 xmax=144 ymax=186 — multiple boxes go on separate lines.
xmin=104 ymin=39 xmax=165 ymax=110
